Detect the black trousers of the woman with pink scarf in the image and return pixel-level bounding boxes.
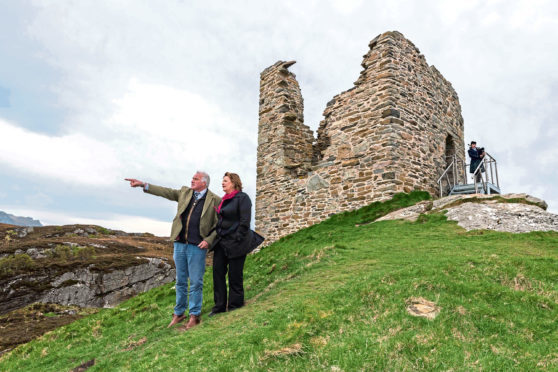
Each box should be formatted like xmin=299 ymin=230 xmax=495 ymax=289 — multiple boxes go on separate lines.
xmin=212 ymin=245 xmax=246 ymax=313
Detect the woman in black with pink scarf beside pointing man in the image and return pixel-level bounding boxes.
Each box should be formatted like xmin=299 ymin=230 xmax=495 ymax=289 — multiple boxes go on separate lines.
xmin=209 ymin=172 xmax=264 ymax=316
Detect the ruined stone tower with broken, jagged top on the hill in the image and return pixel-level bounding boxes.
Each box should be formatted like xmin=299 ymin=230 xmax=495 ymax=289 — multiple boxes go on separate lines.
xmin=256 ymin=32 xmax=465 ymax=242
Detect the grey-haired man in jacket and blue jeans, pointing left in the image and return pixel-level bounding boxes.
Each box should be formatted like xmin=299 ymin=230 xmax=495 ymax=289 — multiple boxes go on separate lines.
xmin=126 ymin=171 xmax=221 ymax=330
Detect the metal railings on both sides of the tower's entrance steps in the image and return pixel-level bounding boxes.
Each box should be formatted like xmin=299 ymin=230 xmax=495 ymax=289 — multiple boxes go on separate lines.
xmin=438 ymin=152 xmax=500 ymax=197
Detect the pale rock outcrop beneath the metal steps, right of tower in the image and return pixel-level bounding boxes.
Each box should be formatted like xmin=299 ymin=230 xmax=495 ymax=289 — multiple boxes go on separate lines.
xmin=376 ymin=194 xmax=558 ymax=233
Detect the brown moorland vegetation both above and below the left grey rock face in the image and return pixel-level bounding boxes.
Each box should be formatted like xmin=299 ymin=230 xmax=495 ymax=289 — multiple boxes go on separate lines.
xmin=0 ymin=224 xmax=177 ymax=354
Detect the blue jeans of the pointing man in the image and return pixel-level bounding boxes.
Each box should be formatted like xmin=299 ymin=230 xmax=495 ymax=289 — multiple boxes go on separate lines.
xmin=173 ymin=242 xmax=207 ymax=315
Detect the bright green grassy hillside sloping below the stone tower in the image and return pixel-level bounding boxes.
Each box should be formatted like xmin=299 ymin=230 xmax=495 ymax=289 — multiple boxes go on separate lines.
xmin=0 ymin=193 xmax=558 ymax=371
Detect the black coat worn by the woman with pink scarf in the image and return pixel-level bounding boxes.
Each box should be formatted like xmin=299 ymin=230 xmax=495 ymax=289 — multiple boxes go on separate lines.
xmin=216 ymin=191 xmax=263 ymax=258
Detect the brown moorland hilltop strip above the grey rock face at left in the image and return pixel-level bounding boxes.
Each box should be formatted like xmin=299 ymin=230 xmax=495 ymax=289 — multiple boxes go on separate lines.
xmin=0 ymin=224 xmax=172 ymax=281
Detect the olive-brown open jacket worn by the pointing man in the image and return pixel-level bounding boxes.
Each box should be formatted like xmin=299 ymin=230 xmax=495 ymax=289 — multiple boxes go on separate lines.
xmin=143 ymin=184 xmax=221 ymax=249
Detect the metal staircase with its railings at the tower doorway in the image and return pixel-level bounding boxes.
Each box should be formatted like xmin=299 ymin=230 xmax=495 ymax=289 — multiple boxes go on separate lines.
xmin=438 ymin=152 xmax=501 ymax=197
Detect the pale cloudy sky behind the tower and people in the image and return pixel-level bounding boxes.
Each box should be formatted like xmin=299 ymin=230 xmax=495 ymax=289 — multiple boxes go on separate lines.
xmin=0 ymin=0 xmax=558 ymax=235
